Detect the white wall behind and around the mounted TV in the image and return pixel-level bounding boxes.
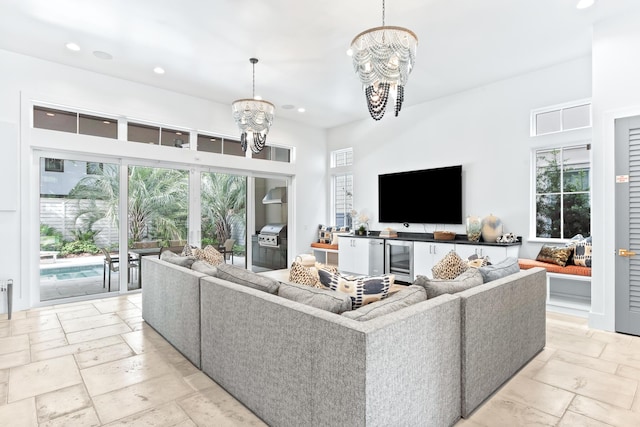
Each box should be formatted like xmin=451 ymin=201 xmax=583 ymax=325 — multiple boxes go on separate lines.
xmin=328 ymin=57 xmax=591 ymax=258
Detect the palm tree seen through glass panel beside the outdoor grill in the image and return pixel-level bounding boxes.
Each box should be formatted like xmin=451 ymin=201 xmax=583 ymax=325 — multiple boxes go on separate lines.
xmin=200 ymin=173 xmax=247 ymax=244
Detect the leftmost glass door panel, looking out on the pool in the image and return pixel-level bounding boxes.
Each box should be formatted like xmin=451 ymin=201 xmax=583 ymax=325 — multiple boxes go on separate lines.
xmin=39 ymin=155 xmax=120 ymax=301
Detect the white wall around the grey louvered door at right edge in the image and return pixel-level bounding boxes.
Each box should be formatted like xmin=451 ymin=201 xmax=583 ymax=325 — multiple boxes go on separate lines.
xmin=589 ymin=13 xmax=640 ymax=330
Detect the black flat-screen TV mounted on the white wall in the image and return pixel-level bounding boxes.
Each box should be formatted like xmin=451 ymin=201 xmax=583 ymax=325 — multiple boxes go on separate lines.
xmin=378 ymin=165 xmax=462 ymax=224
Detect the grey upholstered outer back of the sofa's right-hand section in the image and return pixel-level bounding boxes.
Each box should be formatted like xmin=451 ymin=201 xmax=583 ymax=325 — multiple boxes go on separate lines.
xmin=457 ymin=267 xmax=546 ymax=417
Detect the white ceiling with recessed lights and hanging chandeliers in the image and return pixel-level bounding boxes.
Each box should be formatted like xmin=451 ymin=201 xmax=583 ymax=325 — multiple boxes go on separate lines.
xmin=0 ymin=0 xmax=640 ymax=128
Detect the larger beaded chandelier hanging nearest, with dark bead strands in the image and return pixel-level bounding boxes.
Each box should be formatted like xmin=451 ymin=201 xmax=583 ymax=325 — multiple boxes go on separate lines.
xmin=349 ymin=0 xmax=418 ymax=120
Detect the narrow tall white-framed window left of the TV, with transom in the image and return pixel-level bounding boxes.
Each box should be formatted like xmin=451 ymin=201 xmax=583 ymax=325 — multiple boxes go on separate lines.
xmin=331 ymin=148 xmax=353 ymax=227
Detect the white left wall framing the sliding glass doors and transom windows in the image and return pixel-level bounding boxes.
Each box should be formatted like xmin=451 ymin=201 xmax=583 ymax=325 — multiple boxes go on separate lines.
xmin=0 ymin=50 xmax=327 ymax=313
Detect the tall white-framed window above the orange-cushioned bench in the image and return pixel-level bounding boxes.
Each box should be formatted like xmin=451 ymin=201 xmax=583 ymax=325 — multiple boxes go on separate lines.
xmin=534 ymin=144 xmax=591 ymax=239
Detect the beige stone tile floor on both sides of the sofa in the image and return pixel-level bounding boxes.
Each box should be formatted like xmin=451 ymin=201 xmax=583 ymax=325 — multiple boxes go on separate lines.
xmin=0 ymin=293 xmax=640 ymax=427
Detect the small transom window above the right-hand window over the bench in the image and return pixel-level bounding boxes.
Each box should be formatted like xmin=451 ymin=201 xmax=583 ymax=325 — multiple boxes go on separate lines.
xmin=531 ymin=100 xmax=591 ymax=136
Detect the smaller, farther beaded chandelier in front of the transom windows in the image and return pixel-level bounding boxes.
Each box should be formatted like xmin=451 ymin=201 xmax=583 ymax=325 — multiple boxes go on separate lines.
xmin=231 ymin=58 xmax=276 ymax=153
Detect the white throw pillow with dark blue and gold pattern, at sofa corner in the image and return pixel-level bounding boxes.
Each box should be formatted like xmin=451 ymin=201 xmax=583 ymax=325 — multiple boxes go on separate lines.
xmin=318 ymin=271 xmax=395 ymax=310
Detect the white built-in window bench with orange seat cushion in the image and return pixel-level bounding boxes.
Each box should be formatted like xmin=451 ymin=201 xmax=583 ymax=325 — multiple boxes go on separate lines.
xmin=518 ymin=258 xmax=591 ymax=317
